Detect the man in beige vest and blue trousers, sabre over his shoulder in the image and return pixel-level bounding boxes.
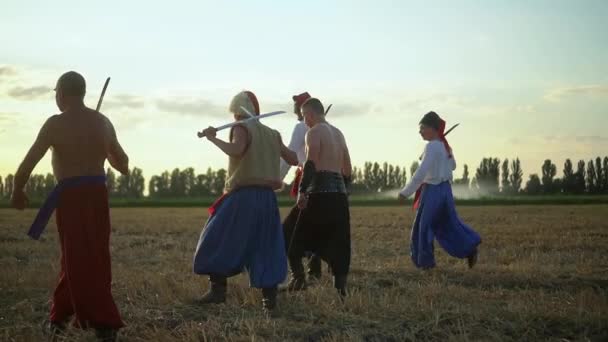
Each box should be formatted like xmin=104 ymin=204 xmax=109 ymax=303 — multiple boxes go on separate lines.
xmin=193 ymin=91 xmax=298 ymax=311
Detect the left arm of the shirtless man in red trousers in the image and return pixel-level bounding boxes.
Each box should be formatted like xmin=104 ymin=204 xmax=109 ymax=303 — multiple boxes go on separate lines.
xmin=11 ymin=117 xmax=54 ymax=210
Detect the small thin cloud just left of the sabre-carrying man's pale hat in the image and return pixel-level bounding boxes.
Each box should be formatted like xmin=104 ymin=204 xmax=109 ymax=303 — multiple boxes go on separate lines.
xmin=156 ymin=97 xmax=228 ymax=117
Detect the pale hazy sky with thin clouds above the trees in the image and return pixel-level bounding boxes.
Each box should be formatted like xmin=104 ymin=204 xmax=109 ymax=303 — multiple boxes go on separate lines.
xmin=0 ymin=0 xmax=608 ymax=184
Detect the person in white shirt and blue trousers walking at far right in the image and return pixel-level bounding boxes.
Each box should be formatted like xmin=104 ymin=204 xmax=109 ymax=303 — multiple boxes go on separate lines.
xmin=399 ymin=112 xmax=481 ymax=269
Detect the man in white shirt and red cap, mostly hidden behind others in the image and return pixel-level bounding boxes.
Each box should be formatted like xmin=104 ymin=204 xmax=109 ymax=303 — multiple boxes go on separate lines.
xmin=281 ymin=92 xmax=321 ymax=291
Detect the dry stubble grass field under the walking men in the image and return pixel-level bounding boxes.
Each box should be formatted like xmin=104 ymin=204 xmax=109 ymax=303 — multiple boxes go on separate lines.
xmin=0 ymin=206 xmax=608 ymax=341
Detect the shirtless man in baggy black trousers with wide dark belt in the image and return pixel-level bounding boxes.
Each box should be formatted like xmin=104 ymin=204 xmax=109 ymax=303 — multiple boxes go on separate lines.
xmin=285 ymin=98 xmax=351 ymax=296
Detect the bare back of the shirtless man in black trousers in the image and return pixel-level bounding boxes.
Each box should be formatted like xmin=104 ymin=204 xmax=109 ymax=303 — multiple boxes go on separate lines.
xmin=306 ymin=122 xmax=351 ymax=176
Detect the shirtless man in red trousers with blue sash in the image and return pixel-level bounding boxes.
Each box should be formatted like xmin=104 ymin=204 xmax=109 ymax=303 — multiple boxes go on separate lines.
xmin=11 ymin=71 xmax=129 ymax=341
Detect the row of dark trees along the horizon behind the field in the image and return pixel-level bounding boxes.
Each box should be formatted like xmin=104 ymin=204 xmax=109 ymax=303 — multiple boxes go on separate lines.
xmin=0 ymin=156 xmax=608 ymax=199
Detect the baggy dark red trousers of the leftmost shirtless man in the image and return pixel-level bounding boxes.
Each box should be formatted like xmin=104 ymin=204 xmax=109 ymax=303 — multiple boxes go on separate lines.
xmin=50 ymin=184 xmax=124 ymax=329
